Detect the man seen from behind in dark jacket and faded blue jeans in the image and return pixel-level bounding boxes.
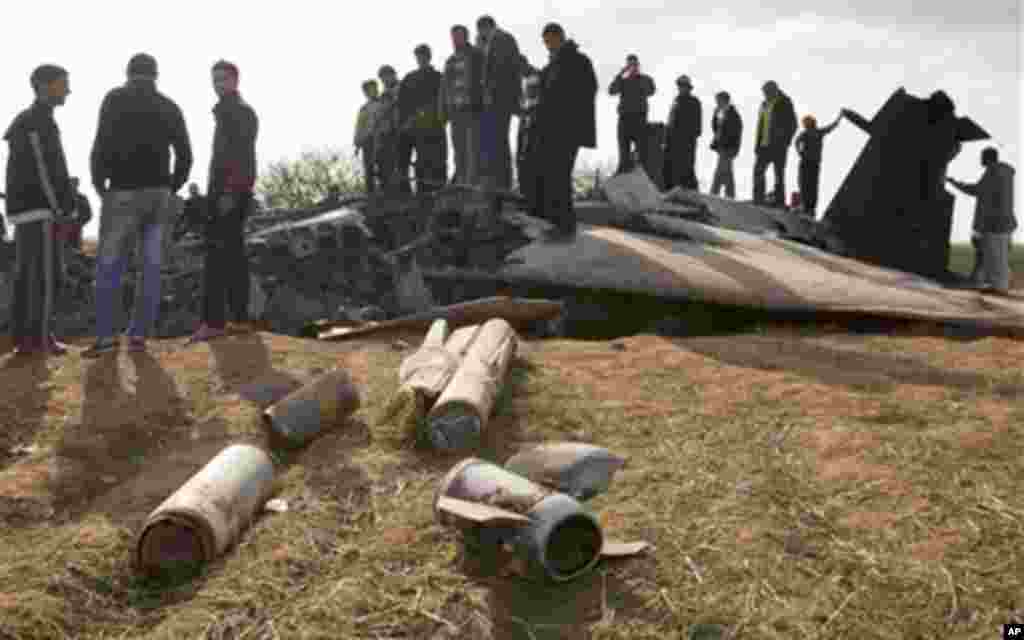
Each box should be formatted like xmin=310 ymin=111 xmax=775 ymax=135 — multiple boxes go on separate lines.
xmin=83 ymin=53 xmax=193 ymax=357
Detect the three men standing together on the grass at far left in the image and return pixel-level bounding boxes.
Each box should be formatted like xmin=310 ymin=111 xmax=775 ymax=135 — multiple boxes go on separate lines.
xmin=4 ymin=53 xmax=259 ymax=357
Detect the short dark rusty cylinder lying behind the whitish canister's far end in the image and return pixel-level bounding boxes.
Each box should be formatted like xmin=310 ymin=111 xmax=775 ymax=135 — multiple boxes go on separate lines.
xmin=263 ymin=369 xmax=359 ymax=446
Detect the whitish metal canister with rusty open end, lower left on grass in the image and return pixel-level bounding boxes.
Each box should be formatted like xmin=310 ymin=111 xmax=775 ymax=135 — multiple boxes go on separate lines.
xmin=135 ymin=444 xmax=273 ymax=573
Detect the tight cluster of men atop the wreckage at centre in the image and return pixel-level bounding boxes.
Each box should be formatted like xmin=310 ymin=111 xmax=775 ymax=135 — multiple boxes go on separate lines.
xmin=353 ymin=15 xmax=598 ymax=240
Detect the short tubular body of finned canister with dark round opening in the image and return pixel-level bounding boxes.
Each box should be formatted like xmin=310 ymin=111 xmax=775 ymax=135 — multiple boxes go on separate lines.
xmin=434 ymin=458 xmax=604 ymax=582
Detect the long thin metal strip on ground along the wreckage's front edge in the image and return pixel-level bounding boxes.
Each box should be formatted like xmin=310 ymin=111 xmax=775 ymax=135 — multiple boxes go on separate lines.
xmin=319 ymin=296 xmax=562 ymax=340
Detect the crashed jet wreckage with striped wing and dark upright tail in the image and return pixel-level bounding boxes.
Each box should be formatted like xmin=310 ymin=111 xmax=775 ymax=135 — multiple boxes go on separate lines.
xmin=0 ymin=89 xmax=1024 ymax=340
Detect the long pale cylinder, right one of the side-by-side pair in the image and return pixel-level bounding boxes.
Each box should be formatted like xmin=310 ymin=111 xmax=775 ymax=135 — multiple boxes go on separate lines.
xmin=427 ymin=317 xmax=519 ymax=451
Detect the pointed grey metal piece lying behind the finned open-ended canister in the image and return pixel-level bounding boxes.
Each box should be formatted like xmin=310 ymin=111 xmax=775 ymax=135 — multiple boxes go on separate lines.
xmin=505 ymin=442 xmax=626 ymax=502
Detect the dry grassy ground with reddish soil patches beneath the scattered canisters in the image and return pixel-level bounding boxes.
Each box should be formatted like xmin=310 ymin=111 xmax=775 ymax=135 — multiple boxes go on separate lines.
xmin=0 ymin=321 xmax=1024 ymax=640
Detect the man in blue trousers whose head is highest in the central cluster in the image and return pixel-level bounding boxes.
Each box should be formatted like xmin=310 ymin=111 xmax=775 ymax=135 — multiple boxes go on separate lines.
xmin=476 ymin=15 xmax=521 ymax=189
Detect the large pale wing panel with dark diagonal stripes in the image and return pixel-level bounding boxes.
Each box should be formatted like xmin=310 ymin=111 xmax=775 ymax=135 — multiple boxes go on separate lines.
xmin=485 ymin=214 xmax=1024 ymax=330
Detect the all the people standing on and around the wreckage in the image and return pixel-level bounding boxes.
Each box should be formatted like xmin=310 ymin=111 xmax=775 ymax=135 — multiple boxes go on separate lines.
xmin=4 ymin=15 xmax=1017 ymax=357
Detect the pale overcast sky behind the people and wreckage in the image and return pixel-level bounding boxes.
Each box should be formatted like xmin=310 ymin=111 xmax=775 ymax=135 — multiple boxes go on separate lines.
xmin=0 ymin=0 xmax=1024 ymax=241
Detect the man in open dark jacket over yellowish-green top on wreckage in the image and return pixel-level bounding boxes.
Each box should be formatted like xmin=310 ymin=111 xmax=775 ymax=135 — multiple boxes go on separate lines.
xmin=754 ymin=80 xmax=797 ymax=207
